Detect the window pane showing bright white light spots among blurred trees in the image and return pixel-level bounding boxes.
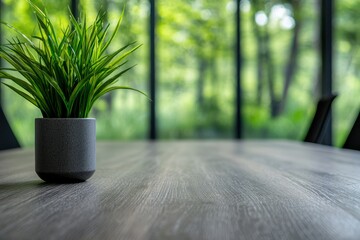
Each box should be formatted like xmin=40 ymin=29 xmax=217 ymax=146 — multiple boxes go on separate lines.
xmin=241 ymin=0 xmax=320 ymax=140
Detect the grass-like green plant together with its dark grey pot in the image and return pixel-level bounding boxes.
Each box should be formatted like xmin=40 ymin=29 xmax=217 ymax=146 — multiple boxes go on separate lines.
xmin=0 ymin=1 xmax=144 ymax=182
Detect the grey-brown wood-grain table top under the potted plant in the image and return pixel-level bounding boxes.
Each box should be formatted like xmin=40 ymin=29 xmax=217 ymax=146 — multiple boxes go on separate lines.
xmin=0 ymin=141 xmax=360 ymax=240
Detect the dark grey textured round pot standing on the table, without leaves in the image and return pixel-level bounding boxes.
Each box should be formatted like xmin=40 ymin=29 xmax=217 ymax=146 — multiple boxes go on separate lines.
xmin=35 ymin=118 xmax=96 ymax=183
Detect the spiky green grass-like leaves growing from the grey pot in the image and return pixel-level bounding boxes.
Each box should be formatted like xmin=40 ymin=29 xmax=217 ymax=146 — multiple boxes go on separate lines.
xmin=0 ymin=1 xmax=145 ymax=118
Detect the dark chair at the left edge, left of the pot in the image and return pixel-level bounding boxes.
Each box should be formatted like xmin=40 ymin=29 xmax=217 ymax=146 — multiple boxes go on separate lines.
xmin=0 ymin=106 xmax=20 ymax=150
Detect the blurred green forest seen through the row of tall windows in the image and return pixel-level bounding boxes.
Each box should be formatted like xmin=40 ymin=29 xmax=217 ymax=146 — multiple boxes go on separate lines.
xmin=2 ymin=0 xmax=360 ymax=146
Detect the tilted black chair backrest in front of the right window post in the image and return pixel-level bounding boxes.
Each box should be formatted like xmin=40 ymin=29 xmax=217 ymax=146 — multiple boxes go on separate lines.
xmin=304 ymin=94 xmax=337 ymax=143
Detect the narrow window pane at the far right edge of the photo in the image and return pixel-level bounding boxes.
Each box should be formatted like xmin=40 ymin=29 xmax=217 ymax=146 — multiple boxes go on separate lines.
xmin=334 ymin=0 xmax=360 ymax=146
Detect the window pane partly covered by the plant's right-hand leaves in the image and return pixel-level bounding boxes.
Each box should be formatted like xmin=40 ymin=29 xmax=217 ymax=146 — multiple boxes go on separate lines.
xmin=81 ymin=0 xmax=149 ymax=140
